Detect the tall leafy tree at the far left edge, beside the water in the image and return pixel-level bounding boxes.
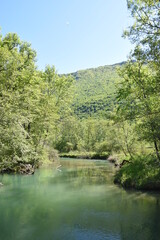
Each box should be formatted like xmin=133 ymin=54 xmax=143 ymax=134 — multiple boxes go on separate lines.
xmin=0 ymin=33 xmax=36 ymax=161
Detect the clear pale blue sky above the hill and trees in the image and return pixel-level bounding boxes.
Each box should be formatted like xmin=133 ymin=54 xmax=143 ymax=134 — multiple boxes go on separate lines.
xmin=0 ymin=0 xmax=131 ymax=73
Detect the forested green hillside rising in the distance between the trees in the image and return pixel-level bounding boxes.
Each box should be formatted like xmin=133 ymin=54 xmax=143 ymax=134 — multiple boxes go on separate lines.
xmin=67 ymin=62 xmax=124 ymax=118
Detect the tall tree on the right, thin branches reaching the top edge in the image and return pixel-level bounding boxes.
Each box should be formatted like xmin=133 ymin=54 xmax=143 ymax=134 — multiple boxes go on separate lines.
xmin=118 ymin=0 xmax=160 ymax=162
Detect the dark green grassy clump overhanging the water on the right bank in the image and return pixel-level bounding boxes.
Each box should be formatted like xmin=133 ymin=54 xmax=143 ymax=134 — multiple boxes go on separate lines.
xmin=114 ymin=157 xmax=160 ymax=191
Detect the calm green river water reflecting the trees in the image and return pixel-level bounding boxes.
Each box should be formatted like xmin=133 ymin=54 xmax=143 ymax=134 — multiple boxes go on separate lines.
xmin=0 ymin=159 xmax=160 ymax=240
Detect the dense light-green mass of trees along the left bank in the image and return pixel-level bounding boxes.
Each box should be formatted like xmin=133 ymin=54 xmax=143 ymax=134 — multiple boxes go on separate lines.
xmin=0 ymin=33 xmax=73 ymax=172
